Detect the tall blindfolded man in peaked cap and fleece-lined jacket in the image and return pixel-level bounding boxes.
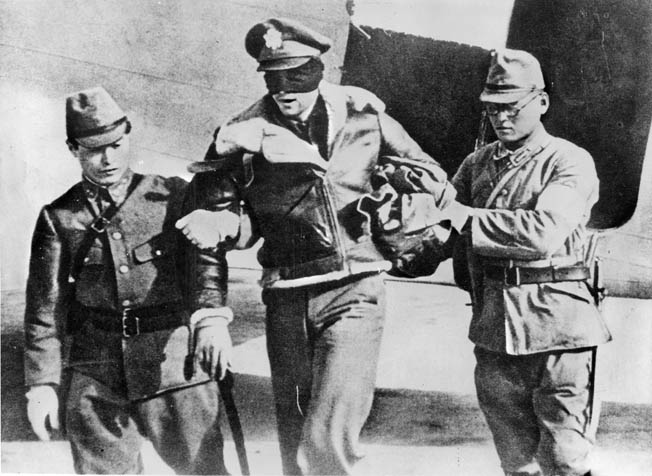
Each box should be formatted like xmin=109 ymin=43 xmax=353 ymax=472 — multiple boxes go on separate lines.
xmin=178 ymin=18 xmax=464 ymax=474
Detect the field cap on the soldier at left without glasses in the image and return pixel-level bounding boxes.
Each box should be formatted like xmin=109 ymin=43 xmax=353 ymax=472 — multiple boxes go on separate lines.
xmin=66 ymin=86 xmax=129 ymax=149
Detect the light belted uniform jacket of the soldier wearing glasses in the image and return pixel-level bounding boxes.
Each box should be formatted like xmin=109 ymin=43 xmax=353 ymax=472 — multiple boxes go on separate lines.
xmin=453 ymin=126 xmax=611 ymax=355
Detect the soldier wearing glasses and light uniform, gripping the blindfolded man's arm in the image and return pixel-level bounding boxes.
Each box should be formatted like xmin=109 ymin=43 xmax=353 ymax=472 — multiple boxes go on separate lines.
xmin=453 ymin=49 xmax=611 ymax=476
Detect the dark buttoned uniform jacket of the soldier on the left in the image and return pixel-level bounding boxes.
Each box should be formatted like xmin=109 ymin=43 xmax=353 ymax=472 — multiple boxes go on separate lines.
xmin=25 ymin=173 xmax=225 ymax=399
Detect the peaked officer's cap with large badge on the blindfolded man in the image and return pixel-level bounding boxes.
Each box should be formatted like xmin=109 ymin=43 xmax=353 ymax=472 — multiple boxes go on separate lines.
xmin=245 ymin=18 xmax=332 ymax=71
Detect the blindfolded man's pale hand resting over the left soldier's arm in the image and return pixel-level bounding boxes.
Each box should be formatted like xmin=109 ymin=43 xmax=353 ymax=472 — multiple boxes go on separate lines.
xmin=175 ymin=210 xmax=240 ymax=249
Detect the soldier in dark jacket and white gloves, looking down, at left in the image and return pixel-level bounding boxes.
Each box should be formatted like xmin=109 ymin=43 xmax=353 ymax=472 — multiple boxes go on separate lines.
xmin=25 ymin=87 xmax=231 ymax=474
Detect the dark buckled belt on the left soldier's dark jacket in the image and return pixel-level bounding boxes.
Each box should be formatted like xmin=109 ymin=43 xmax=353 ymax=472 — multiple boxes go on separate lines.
xmin=77 ymin=303 xmax=186 ymax=337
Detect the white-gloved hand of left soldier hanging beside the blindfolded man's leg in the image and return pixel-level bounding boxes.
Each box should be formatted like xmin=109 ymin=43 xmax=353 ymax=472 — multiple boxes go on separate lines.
xmin=192 ymin=317 xmax=233 ymax=380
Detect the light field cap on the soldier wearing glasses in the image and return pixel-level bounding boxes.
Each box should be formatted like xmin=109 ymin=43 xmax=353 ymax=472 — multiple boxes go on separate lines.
xmin=480 ymin=49 xmax=545 ymax=104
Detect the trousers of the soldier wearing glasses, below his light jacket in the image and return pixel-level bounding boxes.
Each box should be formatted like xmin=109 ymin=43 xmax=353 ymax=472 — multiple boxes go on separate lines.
xmin=475 ymin=347 xmax=598 ymax=476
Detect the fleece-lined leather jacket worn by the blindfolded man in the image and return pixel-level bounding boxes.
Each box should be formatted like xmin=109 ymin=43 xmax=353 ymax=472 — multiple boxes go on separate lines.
xmin=199 ymin=82 xmax=454 ymax=287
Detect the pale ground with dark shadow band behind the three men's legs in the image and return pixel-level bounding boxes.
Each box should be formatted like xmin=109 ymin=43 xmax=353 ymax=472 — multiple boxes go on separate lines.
xmin=0 ymin=269 xmax=652 ymax=476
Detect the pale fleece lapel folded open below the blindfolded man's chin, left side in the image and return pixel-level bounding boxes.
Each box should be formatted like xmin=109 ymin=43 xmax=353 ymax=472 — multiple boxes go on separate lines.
xmin=262 ymin=124 xmax=328 ymax=170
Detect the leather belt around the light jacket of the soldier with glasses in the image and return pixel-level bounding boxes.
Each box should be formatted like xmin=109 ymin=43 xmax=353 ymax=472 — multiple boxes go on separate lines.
xmin=483 ymin=265 xmax=591 ymax=286
